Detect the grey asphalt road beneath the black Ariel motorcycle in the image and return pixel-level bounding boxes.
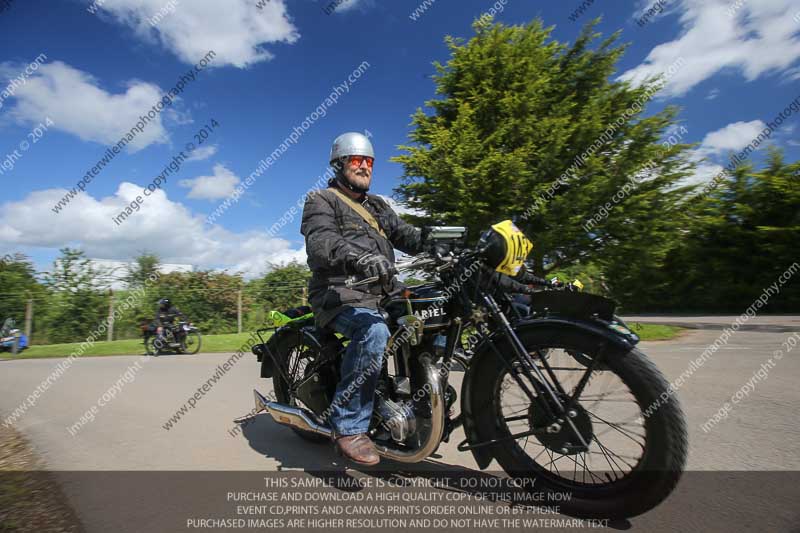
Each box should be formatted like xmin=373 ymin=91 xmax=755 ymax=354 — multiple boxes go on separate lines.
xmin=0 ymin=317 xmax=800 ymax=531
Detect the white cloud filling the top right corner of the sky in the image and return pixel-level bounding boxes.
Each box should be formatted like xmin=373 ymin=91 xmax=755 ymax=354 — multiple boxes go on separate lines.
xmin=620 ymin=0 xmax=800 ymax=96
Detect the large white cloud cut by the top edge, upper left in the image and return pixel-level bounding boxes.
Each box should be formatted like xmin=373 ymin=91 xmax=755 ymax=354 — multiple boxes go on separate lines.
xmin=94 ymin=0 xmax=300 ymax=68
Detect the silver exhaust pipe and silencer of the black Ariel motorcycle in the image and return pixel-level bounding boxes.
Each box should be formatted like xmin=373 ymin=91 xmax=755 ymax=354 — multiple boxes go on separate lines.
xmin=253 ymin=365 xmax=444 ymax=463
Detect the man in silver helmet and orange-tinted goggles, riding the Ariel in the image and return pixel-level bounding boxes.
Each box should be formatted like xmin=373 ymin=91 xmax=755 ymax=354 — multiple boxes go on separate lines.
xmin=300 ymin=133 xmax=425 ymax=465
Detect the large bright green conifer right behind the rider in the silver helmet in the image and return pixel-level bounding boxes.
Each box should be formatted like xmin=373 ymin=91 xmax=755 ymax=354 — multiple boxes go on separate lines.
xmin=394 ymin=20 xmax=692 ymax=275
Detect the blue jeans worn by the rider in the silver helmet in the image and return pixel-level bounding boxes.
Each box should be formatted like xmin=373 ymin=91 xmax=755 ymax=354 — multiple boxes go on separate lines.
xmin=330 ymin=307 xmax=389 ymax=435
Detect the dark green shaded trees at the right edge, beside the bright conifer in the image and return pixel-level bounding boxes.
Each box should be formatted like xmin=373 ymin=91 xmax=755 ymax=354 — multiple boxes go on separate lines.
xmin=648 ymin=150 xmax=800 ymax=313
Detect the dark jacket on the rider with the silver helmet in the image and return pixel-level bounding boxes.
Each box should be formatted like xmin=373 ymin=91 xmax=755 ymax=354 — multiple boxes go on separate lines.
xmin=300 ymin=189 xmax=422 ymax=327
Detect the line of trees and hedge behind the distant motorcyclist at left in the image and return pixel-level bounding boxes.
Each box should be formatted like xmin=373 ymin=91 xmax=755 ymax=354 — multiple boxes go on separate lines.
xmin=0 ymin=248 xmax=310 ymax=344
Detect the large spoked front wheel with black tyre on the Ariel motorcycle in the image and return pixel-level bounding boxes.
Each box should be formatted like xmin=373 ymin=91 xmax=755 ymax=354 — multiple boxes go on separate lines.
xmin=468 ymin=330 xmax=687 ymax=518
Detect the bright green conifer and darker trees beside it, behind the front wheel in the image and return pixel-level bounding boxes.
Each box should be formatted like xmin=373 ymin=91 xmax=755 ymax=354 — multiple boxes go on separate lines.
xmin=393 ymin=20 xmax=800 ymax=313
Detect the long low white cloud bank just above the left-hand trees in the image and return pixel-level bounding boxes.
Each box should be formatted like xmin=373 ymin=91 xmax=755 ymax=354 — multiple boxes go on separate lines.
xmin=0 ymin=182 xmax=306 ymax=277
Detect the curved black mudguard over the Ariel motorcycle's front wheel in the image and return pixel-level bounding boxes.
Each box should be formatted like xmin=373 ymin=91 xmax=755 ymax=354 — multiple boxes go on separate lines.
xmin=461 ymin=317 xmax=635 ymax=469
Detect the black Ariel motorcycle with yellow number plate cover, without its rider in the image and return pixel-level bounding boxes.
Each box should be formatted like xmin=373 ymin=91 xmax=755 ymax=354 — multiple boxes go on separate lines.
xmin=253 ymin=221 xmax=687 ymax=519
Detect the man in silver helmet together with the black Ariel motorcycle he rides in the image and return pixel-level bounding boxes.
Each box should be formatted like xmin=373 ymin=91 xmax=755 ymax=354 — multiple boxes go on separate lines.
xmin=268 ymin=133 xmax=688 ymax=518
